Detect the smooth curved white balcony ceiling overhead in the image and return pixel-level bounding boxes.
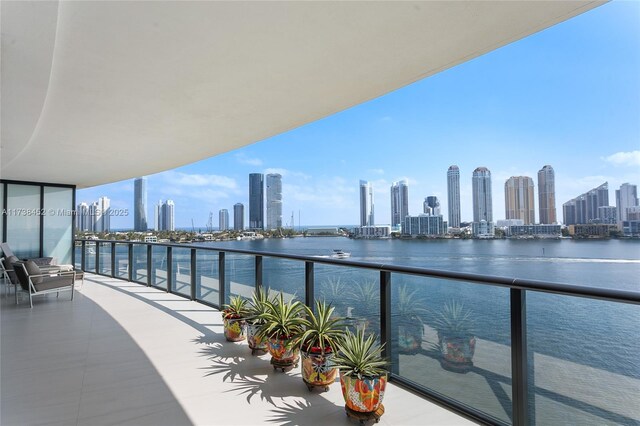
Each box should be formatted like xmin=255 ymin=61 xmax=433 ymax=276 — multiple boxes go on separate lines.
xmin=0 ymin=0 xmax=601 ymax=187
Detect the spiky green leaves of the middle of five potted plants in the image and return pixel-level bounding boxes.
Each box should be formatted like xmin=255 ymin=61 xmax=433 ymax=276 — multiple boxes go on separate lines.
xmin=257 ymin=292 xmax=304 ymax=338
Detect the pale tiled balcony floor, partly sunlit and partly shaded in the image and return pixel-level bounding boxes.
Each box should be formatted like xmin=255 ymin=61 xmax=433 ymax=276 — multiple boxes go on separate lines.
xmin=0 ymin=275 xmax=470 ymax=426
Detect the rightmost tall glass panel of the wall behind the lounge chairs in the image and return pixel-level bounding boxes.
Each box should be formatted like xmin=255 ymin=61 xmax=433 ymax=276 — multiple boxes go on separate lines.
xmin=43 ymin=186 xmax=73 ymax=265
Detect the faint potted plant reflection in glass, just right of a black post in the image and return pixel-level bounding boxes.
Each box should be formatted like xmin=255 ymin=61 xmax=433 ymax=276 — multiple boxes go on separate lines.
xmin=393 ymin=285 xmax=427 ymax=354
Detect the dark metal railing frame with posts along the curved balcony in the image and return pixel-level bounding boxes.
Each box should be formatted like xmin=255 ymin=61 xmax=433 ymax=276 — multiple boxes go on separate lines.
xmin=74 ymin=239 xmax=640 ymax=426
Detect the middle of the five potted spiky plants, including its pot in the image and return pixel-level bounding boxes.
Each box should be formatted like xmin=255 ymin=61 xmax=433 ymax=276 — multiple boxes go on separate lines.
xmin=257 ymin=292 xmax=304 ymax=371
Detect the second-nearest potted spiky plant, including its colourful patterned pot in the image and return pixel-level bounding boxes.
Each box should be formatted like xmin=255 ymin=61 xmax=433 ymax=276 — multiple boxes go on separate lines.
xmin=294 ymin=300 xmax=344 ymax=390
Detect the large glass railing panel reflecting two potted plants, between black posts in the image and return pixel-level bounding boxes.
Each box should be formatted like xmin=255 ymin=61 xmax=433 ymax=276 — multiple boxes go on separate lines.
xmin=391 ymin=273 xmax=512 ymax=423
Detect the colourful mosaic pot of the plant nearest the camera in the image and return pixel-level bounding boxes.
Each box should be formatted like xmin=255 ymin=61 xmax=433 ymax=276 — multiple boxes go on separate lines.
xmin=340 ymin=372 xmax=387 ymax=413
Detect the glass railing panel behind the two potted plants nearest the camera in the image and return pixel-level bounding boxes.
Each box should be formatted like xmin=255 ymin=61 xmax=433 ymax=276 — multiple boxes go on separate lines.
xmin=314 ymin=264 xmax=380 ymax=335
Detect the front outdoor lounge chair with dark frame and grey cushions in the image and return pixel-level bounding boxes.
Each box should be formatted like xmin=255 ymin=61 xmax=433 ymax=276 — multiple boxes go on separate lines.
xmin=13 ymin=260 xmax=76 ymax=308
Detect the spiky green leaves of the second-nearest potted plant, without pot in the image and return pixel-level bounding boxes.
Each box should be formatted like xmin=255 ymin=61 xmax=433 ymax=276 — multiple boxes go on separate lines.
xmin=293 ymin=300 xmax=345 ymax=355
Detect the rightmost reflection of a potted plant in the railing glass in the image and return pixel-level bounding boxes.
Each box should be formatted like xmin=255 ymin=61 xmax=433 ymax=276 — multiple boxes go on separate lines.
xmin=435 ymin=300 xmax=476 ymax=373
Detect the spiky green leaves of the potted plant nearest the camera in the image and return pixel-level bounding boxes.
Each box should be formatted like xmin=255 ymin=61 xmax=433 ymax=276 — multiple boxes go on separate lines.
xmin=333 ymin=329 xmax=387 ymax=380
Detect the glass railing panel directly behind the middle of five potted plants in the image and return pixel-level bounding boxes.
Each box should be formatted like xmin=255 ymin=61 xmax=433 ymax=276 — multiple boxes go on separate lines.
xmin=262 ymin=257 xmax=305 ymax=303
